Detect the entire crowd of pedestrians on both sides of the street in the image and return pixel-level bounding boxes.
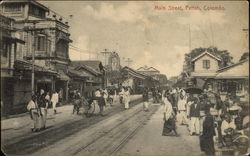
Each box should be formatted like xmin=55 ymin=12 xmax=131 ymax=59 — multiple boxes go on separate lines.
xmin=27 ymin=87 xmax=249 ymax=155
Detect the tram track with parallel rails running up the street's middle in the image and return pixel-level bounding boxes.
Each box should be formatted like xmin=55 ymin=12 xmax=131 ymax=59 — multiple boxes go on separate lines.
xmin=72 ymin=103 xmax=158 ymax=156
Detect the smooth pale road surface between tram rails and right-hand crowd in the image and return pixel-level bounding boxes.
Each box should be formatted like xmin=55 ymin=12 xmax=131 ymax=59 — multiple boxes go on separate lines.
xmin=117 ymin=103 xmax=203 ymax=156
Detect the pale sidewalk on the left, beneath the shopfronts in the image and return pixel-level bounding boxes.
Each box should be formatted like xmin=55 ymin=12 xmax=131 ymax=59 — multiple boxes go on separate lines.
xmin=1 ymin=95 xmax=141 ymax=145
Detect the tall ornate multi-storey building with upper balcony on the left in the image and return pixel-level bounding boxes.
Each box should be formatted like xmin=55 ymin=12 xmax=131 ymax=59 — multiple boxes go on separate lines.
xmin=1 ymin=0 xmax=72 ymax=100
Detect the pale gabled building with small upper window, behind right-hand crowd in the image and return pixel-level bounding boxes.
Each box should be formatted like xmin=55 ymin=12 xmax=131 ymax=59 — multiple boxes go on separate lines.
xmin=190 ymin=52 xmax=249 ymax=100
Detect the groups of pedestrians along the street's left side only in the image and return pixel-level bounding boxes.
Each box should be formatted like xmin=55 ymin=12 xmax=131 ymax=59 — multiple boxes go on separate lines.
xmin=27 ymin=87 xmax=133 ymax=132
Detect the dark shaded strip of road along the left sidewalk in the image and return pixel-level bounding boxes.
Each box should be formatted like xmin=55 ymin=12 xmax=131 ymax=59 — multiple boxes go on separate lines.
xmin=2 ymin=98 xmax=142 ymax=155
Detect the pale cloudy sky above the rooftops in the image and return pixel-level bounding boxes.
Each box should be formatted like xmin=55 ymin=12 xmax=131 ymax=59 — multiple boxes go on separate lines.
xmin=39 ymin=1 xmax=249 ymax=78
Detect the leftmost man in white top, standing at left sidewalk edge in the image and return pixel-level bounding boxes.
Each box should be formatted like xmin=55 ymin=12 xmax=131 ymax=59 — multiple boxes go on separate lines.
xmin=27 ymin=95 xmax=41 ymax=132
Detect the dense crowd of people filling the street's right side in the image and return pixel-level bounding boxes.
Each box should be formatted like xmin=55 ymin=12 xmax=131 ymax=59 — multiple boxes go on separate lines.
xmin=162 ymin=88 xmax=249 ymax=155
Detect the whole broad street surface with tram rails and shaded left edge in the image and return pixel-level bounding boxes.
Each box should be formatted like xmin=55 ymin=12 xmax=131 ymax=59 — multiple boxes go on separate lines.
xmin=2 ymin=97 xmax=205 ymax=156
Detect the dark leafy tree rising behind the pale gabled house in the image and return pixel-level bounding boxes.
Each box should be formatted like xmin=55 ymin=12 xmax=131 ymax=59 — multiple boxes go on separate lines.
xmin=183 ymin=47 xmax=233 ymax=74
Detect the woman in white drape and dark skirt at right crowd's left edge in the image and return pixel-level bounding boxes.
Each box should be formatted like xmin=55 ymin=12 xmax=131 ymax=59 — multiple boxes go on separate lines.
xmin=162 ymin=92 xmax=178 ymax=136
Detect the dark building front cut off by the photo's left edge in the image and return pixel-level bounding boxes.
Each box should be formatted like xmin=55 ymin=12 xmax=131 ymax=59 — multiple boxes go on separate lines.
xmin=0 ymin=15 xmax=25 ymax=115
